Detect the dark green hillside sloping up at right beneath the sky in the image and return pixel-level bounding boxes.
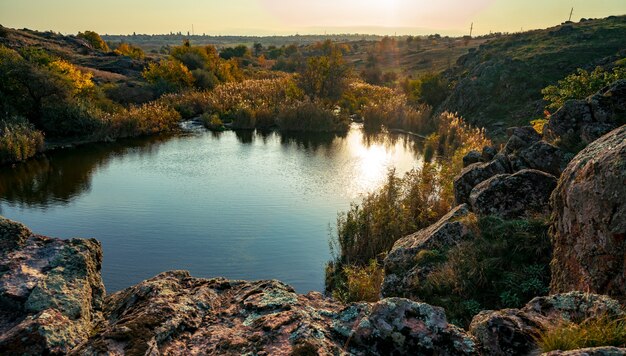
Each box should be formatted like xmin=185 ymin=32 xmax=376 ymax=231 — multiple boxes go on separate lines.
xmin=438 ymin=16 xmax=626 ymax=136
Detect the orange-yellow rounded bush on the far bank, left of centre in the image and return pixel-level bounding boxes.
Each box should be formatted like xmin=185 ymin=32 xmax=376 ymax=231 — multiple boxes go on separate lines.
xmin=143 ymin=59 xmax=194 ymax=94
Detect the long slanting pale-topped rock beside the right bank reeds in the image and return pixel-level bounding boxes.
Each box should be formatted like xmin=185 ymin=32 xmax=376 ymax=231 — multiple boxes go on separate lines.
xmin=382 ymin=204 xmax=470 ymax=297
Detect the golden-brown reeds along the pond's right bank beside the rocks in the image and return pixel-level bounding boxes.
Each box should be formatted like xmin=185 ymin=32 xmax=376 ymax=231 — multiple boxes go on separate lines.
xmin=326 ymin=113 xmax=491 ymax=302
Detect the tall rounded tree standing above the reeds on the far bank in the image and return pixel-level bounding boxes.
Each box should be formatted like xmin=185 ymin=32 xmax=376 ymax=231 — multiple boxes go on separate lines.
xmin=298 ymin=47 xmax=350 ymax=101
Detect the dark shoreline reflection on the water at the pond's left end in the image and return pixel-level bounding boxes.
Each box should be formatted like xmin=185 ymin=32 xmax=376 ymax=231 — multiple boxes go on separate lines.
xmin=0 ymin=136 xmax=170 ymax=213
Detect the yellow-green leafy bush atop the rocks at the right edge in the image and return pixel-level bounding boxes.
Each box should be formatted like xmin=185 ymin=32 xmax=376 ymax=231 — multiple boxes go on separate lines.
xmin=541 ymin=67 xmax=626 ymax=110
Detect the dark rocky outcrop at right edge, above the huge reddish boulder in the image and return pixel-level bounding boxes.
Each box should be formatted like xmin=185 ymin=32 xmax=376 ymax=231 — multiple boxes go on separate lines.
xmin=543 ymin=80 xmax=626 ymax=145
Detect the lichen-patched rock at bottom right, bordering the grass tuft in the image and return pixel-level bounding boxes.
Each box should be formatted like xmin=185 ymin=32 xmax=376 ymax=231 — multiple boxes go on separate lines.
xmin=469 ymin=292 xmax=625 ymax=355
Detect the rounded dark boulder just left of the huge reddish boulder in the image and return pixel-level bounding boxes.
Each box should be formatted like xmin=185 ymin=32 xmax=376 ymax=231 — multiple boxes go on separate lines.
xmin=470 ymin=169 xmax=557 ymax=218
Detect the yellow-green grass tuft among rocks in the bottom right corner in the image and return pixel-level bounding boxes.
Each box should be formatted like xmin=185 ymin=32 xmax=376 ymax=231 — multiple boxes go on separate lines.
xmin=537 ymin=315 xmax=626 ymax=352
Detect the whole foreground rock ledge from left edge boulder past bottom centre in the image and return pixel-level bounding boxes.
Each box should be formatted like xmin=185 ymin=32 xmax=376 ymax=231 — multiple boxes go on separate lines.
xmin=0 ymin=218 xmax=478 ymax=355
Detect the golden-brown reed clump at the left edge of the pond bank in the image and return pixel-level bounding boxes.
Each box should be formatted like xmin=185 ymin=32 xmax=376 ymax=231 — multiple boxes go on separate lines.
xmin=0 ymin=119 xmax=44 ymax=164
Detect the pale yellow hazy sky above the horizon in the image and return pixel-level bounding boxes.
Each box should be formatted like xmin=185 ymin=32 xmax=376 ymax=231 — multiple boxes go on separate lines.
xmin=0 ymin=0 xmax=626 ymax=35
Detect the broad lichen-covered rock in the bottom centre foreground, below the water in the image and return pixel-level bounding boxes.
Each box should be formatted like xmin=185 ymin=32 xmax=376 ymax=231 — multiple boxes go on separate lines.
xmin=75 ymin=271 xmax=476 ymax=355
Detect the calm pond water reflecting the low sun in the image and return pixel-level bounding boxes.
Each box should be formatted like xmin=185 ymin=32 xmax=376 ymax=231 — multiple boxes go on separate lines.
xmin=0 ymin=126 xmax=420 ymax=292
